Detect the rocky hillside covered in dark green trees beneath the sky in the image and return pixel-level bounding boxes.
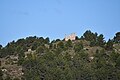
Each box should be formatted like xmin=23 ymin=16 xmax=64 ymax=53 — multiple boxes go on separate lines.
xmin=0 ymin=30 xmax=120 ymax=80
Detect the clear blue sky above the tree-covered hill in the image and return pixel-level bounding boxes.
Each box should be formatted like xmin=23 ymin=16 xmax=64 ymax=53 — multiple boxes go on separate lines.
xmin=0 ymin=0 xmax=120 ymax=46
